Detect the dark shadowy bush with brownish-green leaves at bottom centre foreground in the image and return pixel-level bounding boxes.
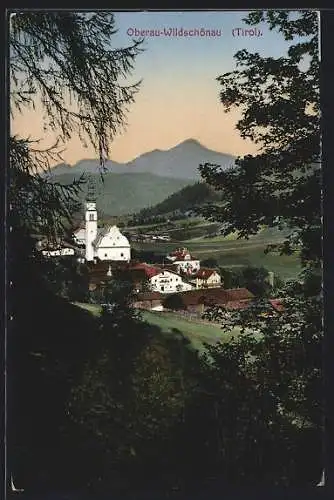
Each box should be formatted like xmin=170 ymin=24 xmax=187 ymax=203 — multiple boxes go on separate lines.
xmin=68 ymin=308 xmax=198 ymax=492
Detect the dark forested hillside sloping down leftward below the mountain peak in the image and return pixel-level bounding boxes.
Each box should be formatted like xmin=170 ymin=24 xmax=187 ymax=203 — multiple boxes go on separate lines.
xmin=136 ymin=182 xmax=221 ymax=218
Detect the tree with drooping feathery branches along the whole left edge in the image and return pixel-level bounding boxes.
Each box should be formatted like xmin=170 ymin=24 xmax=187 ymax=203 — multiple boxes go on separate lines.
xmin=7 ymin=11 xmax=141 ymax=492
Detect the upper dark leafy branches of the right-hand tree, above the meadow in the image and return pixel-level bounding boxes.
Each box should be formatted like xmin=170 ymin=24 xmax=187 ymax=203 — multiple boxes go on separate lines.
xmin=200 ymin=11 xmax=321 ymax=265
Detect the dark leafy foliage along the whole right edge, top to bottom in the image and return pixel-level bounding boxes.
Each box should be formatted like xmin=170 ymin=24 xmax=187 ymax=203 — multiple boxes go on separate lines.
xmin=200 ymin=11 xmax=323 ymax=484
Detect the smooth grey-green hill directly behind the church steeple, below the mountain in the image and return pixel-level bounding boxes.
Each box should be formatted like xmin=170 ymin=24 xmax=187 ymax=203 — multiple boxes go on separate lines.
xmin=51 ymin=173 xmax=189 ymax=216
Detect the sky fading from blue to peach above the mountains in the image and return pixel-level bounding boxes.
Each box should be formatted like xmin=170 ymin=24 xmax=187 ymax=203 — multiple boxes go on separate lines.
xmin=12 ymin=11 xmax=314 ymax=164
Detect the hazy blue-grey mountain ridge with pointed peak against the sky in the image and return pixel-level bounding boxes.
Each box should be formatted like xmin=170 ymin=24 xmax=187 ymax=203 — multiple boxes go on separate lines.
xmin=52 ymin=139 xmax=235 ymax=181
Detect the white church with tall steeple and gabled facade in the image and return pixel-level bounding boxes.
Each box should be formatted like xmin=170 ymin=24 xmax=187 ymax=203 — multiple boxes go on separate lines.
xmin=85 ymin=201 xmax=131 ymax=262
